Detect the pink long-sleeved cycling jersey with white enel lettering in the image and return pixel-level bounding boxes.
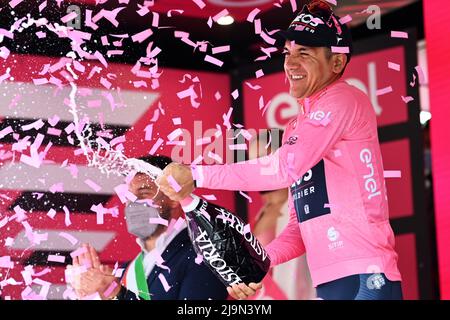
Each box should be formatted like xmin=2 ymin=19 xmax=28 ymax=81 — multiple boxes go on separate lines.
xmin=195 ymin=81 xmax=401 ymax=286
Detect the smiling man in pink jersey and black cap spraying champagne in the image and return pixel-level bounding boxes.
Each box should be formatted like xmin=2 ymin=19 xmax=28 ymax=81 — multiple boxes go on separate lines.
xmin=157 ymin=0 xmax=402 ymax=300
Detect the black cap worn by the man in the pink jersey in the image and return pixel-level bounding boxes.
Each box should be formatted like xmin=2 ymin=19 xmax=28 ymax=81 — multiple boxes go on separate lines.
xmin=273 ymin=5 xmax=353 ymax=60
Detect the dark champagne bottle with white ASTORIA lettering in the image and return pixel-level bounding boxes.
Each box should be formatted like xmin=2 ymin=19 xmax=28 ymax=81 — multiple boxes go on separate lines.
xmin=180 ymin=195 xmax=270 ymax=286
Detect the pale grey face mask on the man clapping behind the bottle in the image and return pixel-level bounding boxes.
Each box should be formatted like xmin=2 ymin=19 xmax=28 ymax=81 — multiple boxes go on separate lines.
xmin=125 ymin=202 xmax=159 ymax=239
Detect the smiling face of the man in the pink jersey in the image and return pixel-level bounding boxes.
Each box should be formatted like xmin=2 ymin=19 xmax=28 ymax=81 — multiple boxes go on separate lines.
xmin=283 ymin=40 xmax=347 ymax=99
